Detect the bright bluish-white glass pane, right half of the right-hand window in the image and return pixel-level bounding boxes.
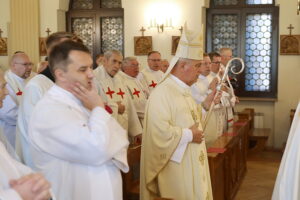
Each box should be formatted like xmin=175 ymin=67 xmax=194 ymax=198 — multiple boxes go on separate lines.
xmin=245 ymin=13 xmax=272 ymax=92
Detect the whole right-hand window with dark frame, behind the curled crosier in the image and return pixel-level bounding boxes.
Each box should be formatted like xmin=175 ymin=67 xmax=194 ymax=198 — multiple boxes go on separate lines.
xmin=206 ymin=0 xmax=279 ymax=98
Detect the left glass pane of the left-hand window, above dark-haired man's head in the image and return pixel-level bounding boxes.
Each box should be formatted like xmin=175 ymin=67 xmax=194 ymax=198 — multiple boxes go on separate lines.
xmin=72 ymin=18 xmax=94 ymax=53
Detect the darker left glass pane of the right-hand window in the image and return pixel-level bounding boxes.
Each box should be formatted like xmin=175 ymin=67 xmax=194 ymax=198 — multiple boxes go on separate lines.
xmin=212 ymin=15 xmax=238 ymax=55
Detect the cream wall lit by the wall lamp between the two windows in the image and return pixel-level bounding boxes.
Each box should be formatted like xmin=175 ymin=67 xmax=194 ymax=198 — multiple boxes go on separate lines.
xmin=122 ymin=0 xmax=204 ymax=67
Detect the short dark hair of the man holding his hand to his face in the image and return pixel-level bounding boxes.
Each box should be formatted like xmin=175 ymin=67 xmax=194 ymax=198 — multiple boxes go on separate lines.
xmin=49 ymin=40 xmax=90 ymax=76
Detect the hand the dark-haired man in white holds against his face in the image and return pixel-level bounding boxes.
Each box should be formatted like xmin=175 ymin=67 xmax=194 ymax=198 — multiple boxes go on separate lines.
xmin=71 ymin=82 xmax=104 ymax=110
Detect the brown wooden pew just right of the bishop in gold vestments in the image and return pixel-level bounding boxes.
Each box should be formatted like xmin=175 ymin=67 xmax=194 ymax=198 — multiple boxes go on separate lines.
xmin=207 ymin=119 xmax=250 ymax=200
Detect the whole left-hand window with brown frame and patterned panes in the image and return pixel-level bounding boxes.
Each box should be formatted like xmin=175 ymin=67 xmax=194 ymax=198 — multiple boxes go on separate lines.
xmin=67 ymin=0 xmax=124 ymax=57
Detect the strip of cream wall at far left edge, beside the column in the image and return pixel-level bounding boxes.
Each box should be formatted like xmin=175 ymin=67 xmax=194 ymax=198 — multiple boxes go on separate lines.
xmin=0 ymin=0 xmax=10 ymax=69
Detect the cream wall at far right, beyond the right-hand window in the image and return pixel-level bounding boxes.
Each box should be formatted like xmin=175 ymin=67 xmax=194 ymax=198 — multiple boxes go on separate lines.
xmin=274 ymin=0 xmax=300 ymax=147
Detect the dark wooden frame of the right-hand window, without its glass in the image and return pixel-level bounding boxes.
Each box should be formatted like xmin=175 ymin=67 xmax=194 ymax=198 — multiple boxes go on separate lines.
xmin=206 ymin=0 xmax=279 ymax=98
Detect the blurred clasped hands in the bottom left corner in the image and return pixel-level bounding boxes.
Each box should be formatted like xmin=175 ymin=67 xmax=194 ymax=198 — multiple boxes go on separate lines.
xmin=9 ymin=173 xmax=51 ymax=200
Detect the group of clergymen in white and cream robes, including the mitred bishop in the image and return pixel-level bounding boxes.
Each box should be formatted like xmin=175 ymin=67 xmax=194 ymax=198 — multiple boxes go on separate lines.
xmin=0 ymin=23 xmax=238 ymax=200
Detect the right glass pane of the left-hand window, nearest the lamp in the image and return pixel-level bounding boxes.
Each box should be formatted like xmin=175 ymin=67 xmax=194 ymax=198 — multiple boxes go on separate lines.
xmin=101 ymin=17 xmax=123 ymax=52
